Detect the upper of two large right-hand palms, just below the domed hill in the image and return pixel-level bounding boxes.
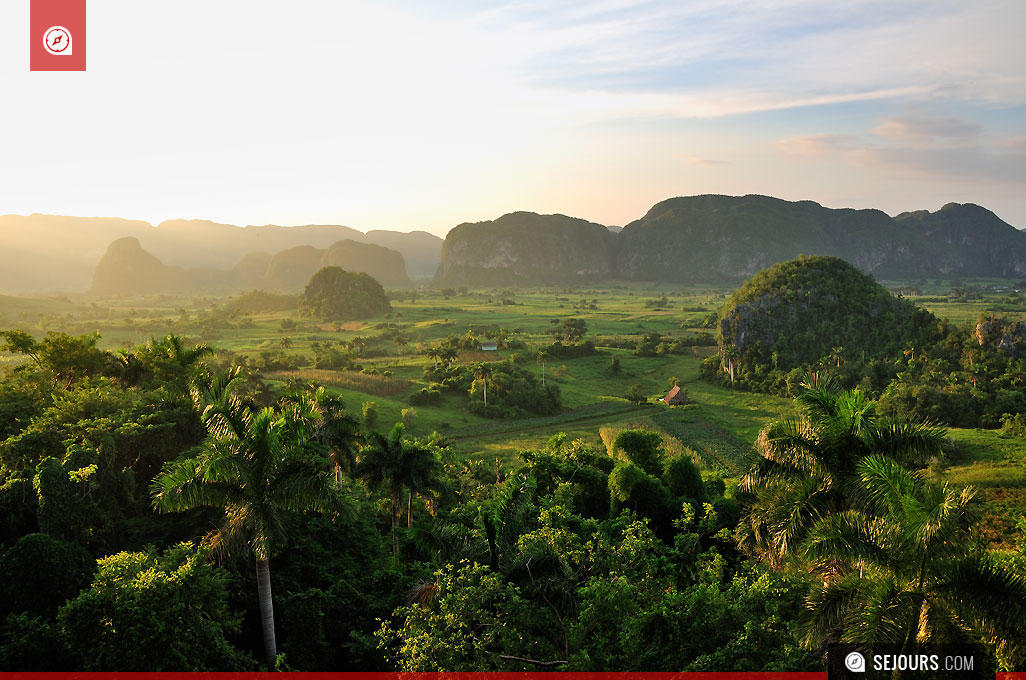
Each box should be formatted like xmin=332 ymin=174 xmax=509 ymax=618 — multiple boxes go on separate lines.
xmin=739 ymin=381 xmax=946 ymax=565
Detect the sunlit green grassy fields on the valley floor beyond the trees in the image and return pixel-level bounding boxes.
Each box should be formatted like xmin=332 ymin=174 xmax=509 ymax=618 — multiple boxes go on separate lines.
xmin=0 ymin=282 xmax=1026 ymax=548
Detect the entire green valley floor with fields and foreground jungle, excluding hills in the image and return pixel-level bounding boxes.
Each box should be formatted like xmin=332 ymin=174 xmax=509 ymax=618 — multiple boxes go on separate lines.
xmin=0 ymin=270 xmax=1026 ymax=671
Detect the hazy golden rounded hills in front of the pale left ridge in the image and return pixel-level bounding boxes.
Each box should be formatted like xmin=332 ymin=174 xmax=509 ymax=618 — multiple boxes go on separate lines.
xmin=90 ymin=236 xmax=411 ymax=296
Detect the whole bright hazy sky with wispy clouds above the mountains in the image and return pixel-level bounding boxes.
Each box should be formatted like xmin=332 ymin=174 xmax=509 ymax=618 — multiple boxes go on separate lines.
xmin=0 ymin=0 xmax=1026 ymax=235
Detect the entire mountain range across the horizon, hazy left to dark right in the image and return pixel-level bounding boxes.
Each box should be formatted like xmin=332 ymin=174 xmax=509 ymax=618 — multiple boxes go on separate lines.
xmin=0 ymin=195 xmax=1026 ymax=294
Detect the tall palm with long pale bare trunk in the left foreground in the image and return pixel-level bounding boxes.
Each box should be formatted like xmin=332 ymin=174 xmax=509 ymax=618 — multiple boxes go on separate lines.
xmin=151 ymin=370 xmax=350 ymax=669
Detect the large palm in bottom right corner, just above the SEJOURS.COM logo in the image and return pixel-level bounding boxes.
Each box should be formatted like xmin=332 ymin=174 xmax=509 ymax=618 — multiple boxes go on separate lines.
xmin=802 ymin=455 xmax=1026 ymax=662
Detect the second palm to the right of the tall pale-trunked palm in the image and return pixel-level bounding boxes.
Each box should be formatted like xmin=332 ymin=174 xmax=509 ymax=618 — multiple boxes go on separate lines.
xmin=357 ymin=423 xmax=441 ymax=557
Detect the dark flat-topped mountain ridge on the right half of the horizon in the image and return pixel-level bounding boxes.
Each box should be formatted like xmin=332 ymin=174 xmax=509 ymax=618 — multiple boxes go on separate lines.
xmin=435 ymin=195 xmax=1026 ymax=285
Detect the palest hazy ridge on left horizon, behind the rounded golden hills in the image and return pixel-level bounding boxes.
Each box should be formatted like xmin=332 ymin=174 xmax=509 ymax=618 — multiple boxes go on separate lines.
xmin=0 ymin=214 xmax=442 ymax=292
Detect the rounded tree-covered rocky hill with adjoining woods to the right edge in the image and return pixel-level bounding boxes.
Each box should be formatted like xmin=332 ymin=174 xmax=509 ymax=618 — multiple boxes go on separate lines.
xmin=704 ymin=257 xmax=1026 ymax=428
